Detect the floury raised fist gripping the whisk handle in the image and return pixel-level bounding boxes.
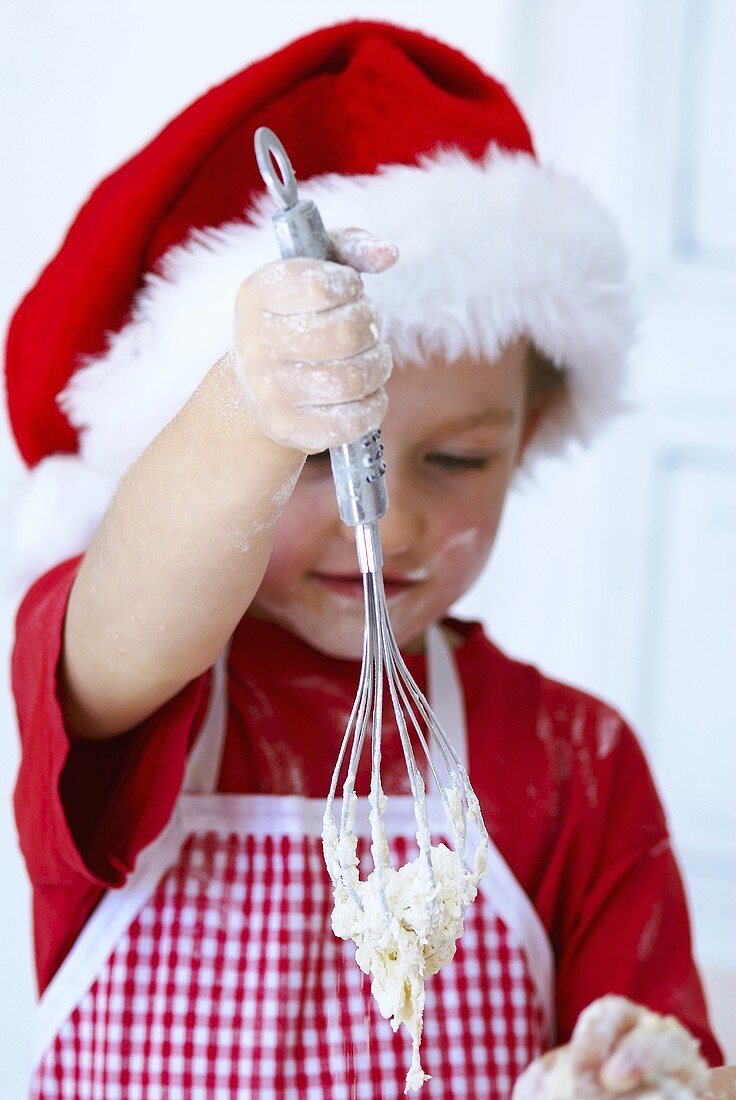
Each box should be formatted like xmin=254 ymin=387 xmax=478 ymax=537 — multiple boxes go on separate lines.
xmin=235 ymin=229 xmax=398 ymax=454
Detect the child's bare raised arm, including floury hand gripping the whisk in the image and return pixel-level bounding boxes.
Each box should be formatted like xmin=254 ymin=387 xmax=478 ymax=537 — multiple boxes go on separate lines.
xmin=59 ymin=231 xmax=397 ymax=738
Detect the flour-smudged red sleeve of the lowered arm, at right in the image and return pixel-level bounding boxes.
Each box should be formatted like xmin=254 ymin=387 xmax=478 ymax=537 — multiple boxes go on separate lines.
xmin=547 ymin=701 xmax=723 ymax=1065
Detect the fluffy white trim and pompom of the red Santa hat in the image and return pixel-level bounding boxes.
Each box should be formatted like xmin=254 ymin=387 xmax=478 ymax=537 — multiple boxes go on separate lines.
xmin=8 ymin=146 xmax=635 ymax=594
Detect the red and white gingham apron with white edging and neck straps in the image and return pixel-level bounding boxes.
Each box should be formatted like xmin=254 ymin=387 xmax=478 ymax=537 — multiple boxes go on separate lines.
xmin=31 ymin=627 xmax=553 ymax=1100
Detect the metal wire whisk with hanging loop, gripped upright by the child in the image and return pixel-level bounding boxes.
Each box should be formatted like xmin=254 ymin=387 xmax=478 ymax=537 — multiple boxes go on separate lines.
xmin=255 ymin=127 xmax=487 ymax=1003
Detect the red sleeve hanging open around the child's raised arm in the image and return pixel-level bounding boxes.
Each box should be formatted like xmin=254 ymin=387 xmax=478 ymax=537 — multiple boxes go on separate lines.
xmin=11 ymin=557 xmax=210 ymax=889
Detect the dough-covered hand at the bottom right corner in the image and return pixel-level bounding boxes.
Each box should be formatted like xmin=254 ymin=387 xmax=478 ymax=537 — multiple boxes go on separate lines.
xmin=513 ymin=997 xmax=707 ymax=1100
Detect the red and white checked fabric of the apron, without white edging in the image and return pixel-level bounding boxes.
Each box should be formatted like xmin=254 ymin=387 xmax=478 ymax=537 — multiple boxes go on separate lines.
xmin=31 ymin=832 xmax=546 ymax=1100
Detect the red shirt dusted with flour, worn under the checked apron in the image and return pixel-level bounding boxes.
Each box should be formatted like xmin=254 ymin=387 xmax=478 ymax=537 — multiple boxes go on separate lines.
xmin=12 ymin=558 xmax=722 ymax=1064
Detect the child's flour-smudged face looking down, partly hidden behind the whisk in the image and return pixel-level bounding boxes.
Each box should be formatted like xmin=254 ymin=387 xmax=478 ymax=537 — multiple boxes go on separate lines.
xmin=251 ymin=341 xmax=532 ymax=660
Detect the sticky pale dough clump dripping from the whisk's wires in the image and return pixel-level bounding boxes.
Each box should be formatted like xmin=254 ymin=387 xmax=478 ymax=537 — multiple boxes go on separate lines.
xmin=332 ymin=844 xmax=477 ymax=1091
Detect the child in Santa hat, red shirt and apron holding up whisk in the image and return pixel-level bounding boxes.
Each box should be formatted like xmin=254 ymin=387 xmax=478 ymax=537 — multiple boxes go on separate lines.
xmin=8 ymin=22 xmax=718 ymax=1100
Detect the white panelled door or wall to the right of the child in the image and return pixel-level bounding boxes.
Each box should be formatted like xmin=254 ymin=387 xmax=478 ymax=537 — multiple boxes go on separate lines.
xmin=453 ymin=0 xmax=736 ymax=1058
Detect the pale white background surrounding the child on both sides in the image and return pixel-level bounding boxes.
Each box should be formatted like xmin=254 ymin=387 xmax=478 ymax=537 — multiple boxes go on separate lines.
xmin=0 ymin=0 xmax=736 ymax=1098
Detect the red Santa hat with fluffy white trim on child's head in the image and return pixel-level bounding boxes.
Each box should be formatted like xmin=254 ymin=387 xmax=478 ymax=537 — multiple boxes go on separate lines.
xmin=6 ymin=21 xmax=634 ymax=581
